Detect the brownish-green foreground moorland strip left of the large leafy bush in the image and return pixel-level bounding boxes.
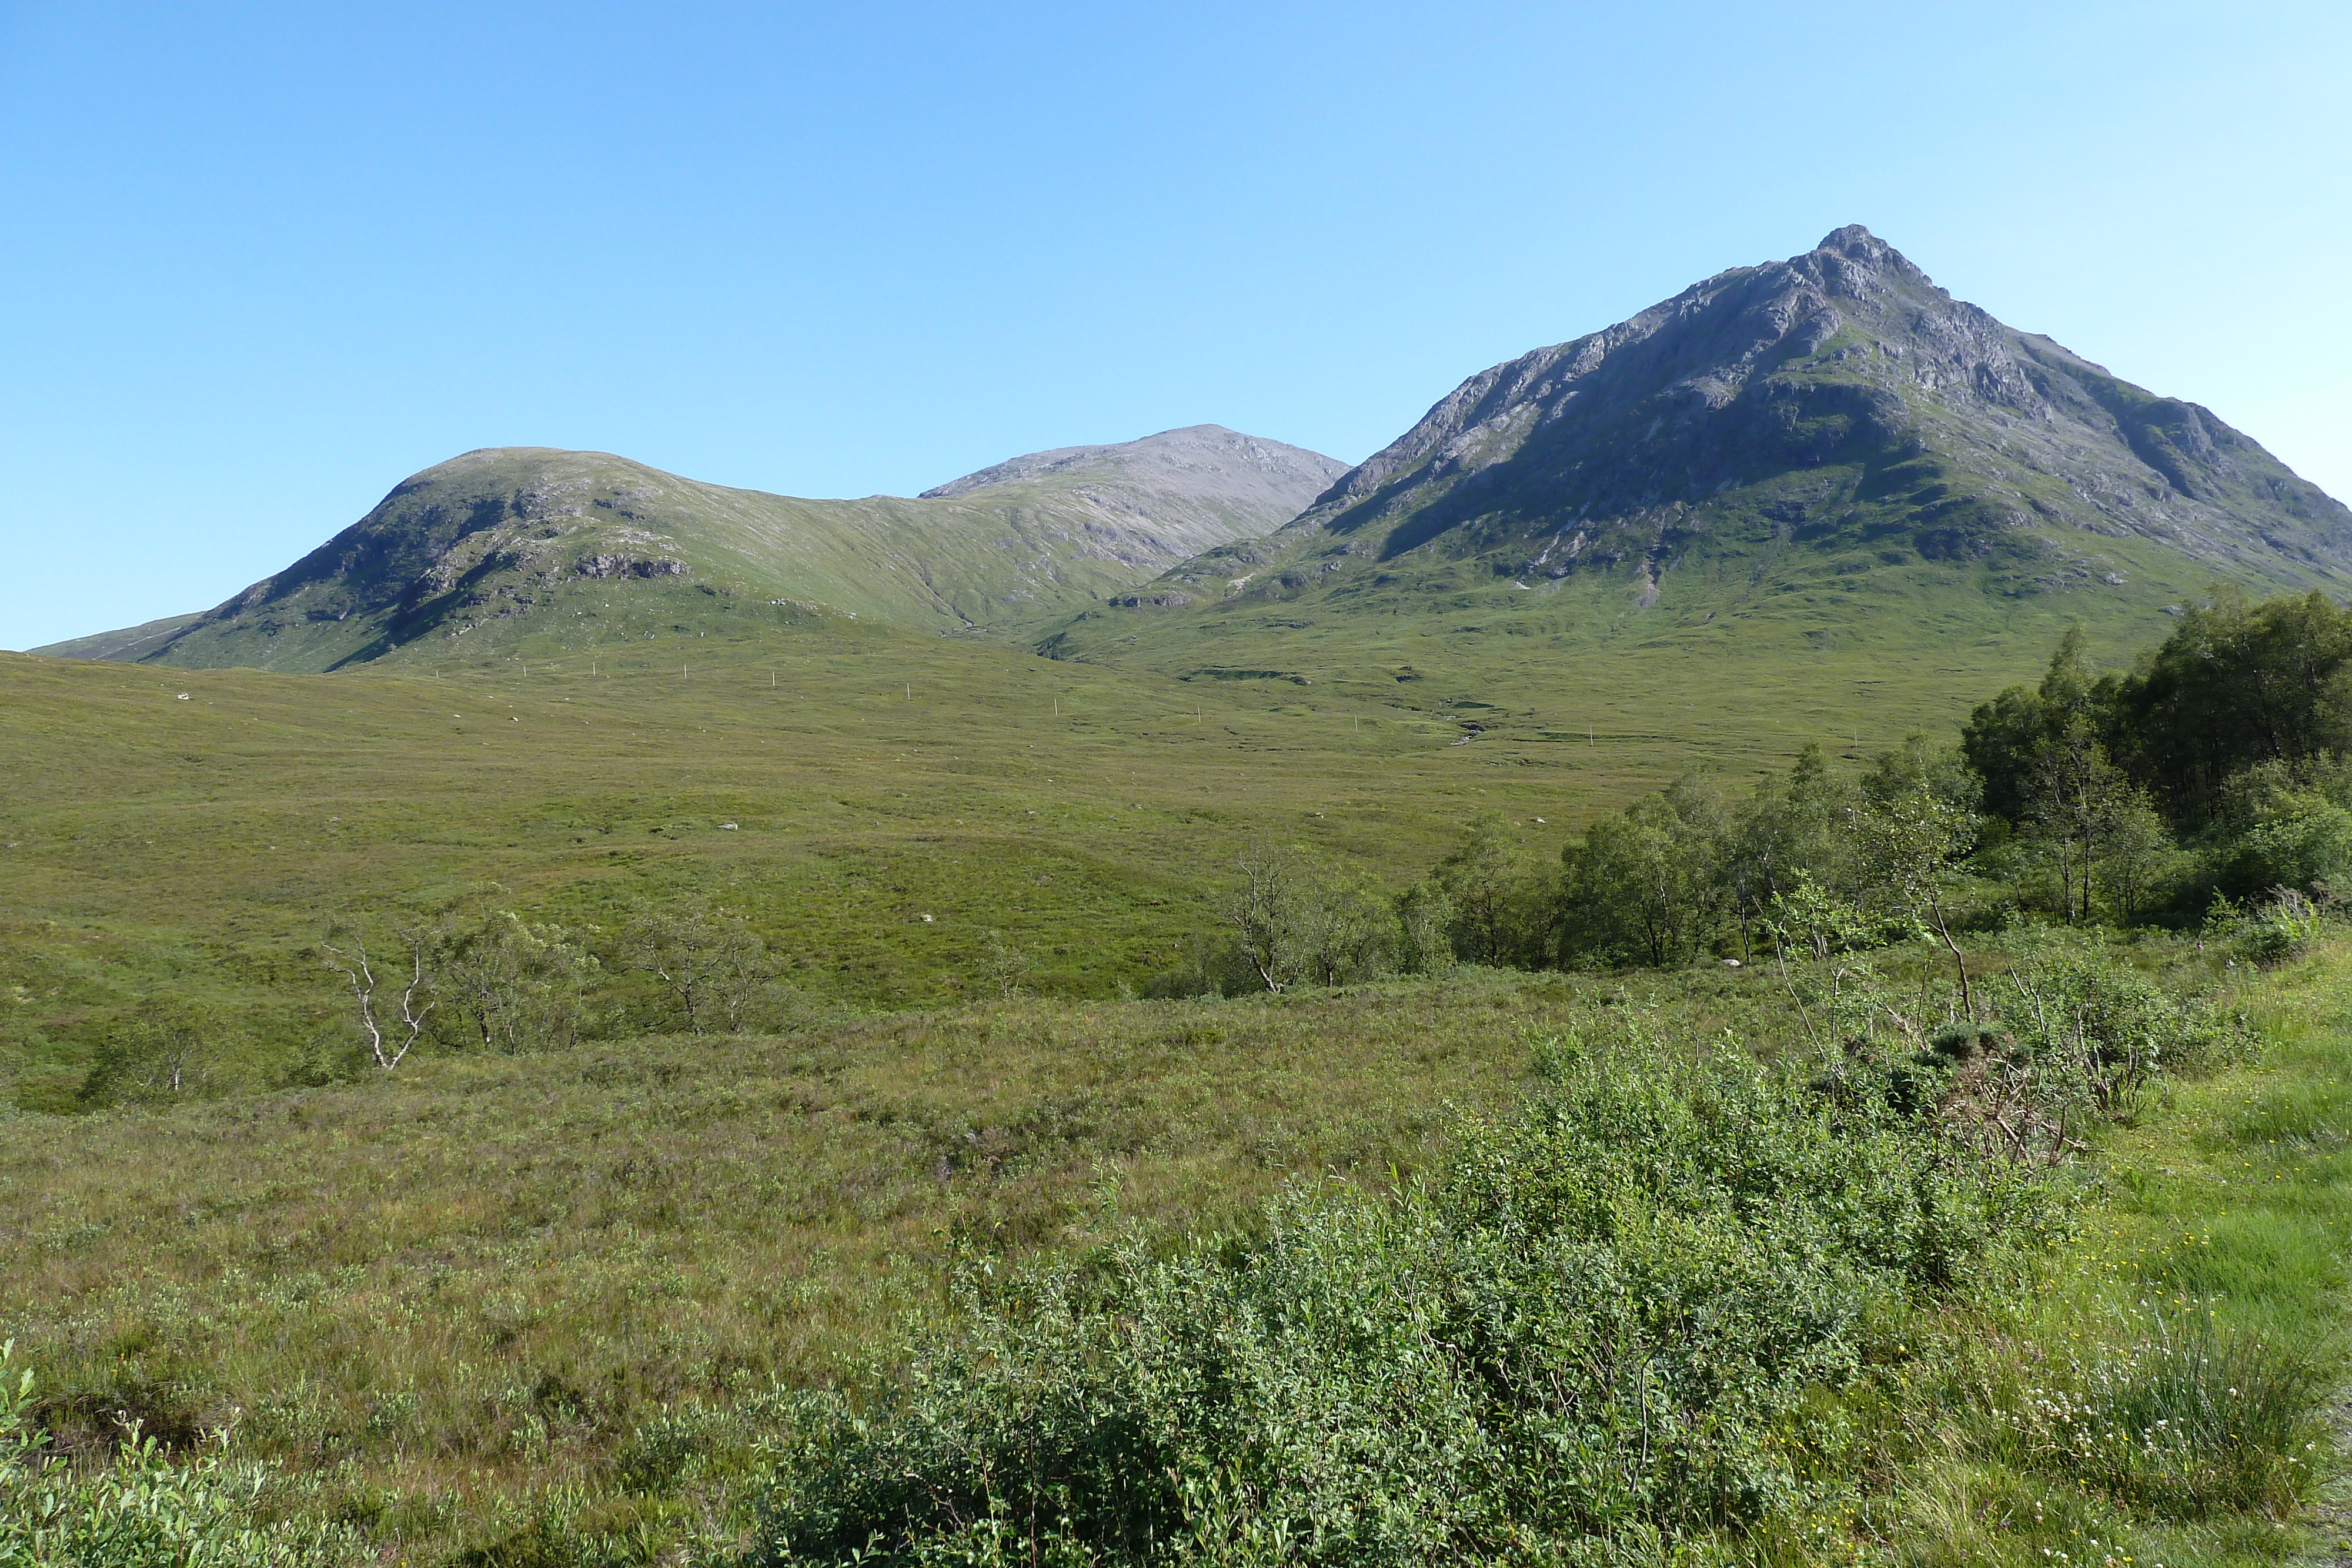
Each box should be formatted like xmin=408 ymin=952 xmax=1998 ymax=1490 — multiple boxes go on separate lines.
xmin=0 ymin=980 xmax=1569 ymax=1540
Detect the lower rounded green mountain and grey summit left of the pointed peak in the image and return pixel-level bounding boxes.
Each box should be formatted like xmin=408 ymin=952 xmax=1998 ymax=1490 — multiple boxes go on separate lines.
xmin=35 ymin=426 xmax=1343 ymax=670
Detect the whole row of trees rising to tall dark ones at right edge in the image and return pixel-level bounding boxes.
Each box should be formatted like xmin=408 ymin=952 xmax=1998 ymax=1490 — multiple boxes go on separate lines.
xmin=1176 ymin=593 xmax=2352 ymax=994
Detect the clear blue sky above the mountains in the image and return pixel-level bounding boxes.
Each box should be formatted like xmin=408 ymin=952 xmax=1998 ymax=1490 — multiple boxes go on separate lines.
xmin=0 ymin=0 xmax=2352 ymax=647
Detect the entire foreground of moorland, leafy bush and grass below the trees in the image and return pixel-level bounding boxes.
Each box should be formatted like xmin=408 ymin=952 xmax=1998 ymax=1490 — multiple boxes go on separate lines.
xmin=18 ymin=940 xmax=2352 ymax=1563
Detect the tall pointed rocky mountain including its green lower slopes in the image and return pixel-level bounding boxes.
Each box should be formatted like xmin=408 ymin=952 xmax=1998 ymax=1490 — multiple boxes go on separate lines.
xmin=1035 ymin=228 xmax=2352 ymax=734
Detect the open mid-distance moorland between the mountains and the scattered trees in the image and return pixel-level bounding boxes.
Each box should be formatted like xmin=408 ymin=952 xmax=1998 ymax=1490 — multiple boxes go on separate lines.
xmin=0 ymin=597 xmax=2046 ymax=1109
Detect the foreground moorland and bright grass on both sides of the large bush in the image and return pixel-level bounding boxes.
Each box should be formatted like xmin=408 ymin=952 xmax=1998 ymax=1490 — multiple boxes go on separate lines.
xmin=0 ymin=938 xmax=2352 ymax=1563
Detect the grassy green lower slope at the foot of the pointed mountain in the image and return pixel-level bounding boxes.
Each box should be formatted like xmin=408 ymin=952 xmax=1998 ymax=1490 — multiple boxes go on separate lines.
xmin=1040 ymin=503 xmax=2227 ymax=747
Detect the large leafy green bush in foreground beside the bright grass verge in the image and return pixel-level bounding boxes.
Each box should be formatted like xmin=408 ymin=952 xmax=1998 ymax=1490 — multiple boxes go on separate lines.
xmin=762 ymin=1041 xmax=2051 ymax=1566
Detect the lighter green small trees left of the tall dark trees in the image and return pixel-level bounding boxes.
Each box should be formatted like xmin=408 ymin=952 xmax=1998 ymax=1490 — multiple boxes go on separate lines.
xmin=1150 ymin=741 xmax=1976 ymax=994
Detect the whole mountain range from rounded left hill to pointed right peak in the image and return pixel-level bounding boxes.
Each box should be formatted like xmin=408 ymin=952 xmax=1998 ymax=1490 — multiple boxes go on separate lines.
xmin=28 ymin=226 xmax=2352 ymax=705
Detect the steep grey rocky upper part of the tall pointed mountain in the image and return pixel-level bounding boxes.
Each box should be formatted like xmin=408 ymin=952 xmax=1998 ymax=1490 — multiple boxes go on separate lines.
xmin=1289 ymin=226 xmax=2352 ymax=594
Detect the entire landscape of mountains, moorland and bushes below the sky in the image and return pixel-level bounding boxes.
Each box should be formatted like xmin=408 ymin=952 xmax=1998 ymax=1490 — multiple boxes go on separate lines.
xmin=0 ymin=228 xmax=2352 ymax=1568
